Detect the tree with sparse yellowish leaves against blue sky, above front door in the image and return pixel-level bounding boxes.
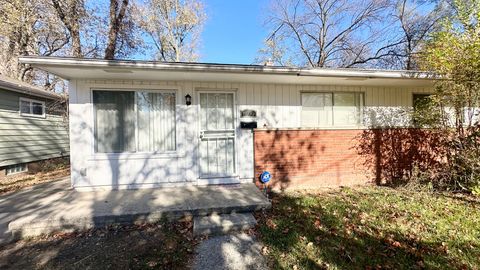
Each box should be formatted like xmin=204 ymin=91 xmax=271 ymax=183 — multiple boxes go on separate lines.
xmin=139 ymin=0 xmax=206 ymax=62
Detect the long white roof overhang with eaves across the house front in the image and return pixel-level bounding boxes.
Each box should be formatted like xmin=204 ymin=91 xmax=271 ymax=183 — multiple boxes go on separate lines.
xmin=19 ymin=56 xmax=434 ymax=86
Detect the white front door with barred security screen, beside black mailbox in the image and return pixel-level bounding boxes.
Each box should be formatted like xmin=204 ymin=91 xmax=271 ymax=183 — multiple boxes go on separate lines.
xmin=199 ymin=92 xmax=236 ymax=179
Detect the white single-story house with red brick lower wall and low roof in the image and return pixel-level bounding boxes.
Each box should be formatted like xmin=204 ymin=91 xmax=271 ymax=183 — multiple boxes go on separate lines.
xmin=20 ymin=57 xmax=433 ymax=189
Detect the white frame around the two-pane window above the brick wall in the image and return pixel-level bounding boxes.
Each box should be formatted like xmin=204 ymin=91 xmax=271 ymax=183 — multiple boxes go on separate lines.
xmin=300 ymin=91 xmax=365 ymax=129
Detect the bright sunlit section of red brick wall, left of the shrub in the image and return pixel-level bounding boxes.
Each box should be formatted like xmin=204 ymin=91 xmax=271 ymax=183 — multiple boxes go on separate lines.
xmin=254 ymin=130 xmax=371 ymax=189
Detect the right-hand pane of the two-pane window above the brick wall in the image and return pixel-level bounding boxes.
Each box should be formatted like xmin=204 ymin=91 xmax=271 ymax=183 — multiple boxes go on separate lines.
xmin=333 ymin=93 xmax=363 ymax=126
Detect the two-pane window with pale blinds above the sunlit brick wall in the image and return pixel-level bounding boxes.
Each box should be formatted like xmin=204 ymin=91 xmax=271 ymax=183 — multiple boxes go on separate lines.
xmin=301 ymin=92 xmax=363 ymax=127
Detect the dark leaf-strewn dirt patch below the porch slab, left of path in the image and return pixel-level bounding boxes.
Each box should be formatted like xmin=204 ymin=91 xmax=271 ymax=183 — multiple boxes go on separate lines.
xmin=0 ymin=220 xmax=199 ymax=269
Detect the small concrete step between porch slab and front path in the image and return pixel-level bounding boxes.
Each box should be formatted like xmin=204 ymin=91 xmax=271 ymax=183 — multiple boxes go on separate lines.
xmin=193 ymin=213 xmax=257 ymax=235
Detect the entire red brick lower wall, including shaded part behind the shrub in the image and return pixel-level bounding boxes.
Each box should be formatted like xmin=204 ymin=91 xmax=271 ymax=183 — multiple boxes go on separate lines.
xmin=254 ymin=128 xmax=445 ymax=189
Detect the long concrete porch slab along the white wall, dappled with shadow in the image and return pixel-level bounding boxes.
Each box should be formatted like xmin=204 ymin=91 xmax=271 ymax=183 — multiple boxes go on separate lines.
xmin=0 ymin=179 xmax=270 ymax=244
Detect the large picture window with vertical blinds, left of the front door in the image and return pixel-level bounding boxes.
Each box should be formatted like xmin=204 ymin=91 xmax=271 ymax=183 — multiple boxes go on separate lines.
xmin=93 ymin=91 xmax=176 ymax=153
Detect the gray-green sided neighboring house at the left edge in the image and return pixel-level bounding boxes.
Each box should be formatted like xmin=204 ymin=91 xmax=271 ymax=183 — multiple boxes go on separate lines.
xmin=0 ymin=75 xmax=70 ymax=179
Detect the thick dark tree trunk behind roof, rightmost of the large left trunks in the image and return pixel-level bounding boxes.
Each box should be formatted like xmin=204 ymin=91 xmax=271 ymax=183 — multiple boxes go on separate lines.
xmin=105 ymin=0 xmax=128 ymax=60
